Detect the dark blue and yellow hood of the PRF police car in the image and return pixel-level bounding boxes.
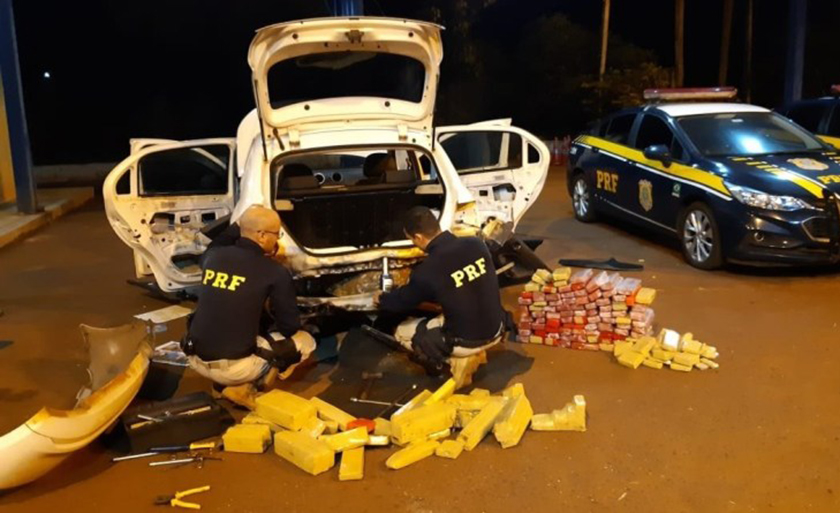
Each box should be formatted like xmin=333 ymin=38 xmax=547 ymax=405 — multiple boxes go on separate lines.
xmin=711 ymin=151 xmax=840 ymax=200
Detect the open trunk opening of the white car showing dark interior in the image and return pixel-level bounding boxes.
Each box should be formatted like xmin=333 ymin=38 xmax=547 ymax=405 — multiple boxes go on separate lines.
xmin=273 ymin=148 xmax=444 ymax=251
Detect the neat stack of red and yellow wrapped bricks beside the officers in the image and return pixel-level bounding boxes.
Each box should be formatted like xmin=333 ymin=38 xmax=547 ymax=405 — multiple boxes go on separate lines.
xmin=517 ymin=267 xmax=656 ymax=351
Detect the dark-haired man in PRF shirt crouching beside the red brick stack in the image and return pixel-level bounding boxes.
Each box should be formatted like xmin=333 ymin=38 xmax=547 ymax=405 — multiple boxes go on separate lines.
xmin=378 ymin=207 xmax=510 ymax=387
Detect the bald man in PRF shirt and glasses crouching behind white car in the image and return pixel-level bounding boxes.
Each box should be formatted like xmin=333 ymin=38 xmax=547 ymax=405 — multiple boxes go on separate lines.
xmin=184 ymin=206 xmax=315 ymax=408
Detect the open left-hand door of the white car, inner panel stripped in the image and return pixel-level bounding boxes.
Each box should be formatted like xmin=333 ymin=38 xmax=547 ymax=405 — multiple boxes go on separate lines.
xmin=102 ymin=138 xmax=236 ymax=292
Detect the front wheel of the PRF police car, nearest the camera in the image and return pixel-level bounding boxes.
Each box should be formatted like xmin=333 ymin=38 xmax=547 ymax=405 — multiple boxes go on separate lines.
xmin=679 ymin=202 xmax=723 ymax=270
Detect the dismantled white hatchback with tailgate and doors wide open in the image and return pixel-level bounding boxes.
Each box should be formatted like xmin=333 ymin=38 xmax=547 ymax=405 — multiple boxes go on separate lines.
xmin=103 ymin=18 xmax=549 ymax=311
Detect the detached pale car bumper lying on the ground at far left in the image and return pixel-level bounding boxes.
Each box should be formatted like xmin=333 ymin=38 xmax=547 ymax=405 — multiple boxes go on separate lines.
xmin=0 ymin=321 xmax=151 ymax=490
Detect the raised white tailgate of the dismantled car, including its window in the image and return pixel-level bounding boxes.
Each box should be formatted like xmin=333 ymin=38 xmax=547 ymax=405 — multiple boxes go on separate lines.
xmin=248 ymin=17 xmax=443 ymax=138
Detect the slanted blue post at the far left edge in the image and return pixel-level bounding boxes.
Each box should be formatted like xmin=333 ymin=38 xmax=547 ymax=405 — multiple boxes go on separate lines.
xmin=0 ymin=0 xmax=38 ymax=214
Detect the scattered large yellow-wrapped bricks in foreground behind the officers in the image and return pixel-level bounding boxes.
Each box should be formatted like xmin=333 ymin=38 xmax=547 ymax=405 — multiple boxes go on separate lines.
xmin=222 ymin=379 xmax=586 ymax=481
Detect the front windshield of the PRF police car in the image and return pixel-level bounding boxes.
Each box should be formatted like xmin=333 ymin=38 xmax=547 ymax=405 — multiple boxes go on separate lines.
xmin=677 ymin=112 xmax=823 ymax=157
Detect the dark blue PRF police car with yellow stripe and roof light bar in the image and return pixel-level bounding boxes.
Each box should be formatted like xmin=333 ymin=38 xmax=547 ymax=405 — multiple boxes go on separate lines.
xmin=568 ymin=88 xmax=840 ymax=269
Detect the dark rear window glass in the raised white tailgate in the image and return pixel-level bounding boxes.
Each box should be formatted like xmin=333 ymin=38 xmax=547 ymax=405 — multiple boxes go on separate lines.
xmin=268 ymin=52 xmax=426 ymax=109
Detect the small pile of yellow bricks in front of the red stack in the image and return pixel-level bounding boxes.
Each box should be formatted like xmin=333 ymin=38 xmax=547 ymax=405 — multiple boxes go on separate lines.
xmin=613 ymin=329 xmax=719 ymax=372
